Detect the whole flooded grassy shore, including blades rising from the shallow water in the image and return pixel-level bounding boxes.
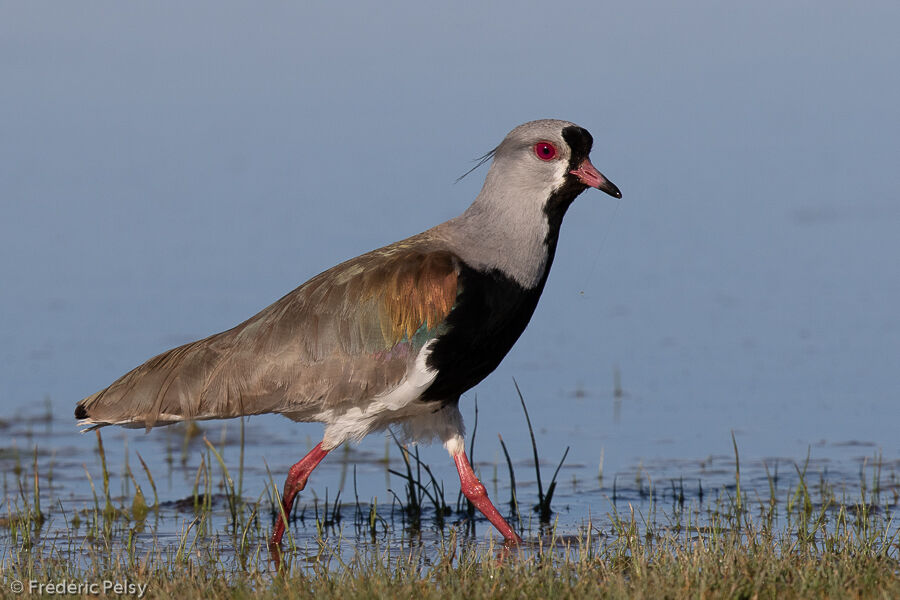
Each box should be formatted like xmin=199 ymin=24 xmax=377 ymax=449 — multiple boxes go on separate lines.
xmin=0 ymin=395 xmax=900 ymax=600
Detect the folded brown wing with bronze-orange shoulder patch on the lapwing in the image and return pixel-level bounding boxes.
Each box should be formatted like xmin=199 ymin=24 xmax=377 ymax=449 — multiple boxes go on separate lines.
xmin=75 ymin=236 xmax=458 ymax=428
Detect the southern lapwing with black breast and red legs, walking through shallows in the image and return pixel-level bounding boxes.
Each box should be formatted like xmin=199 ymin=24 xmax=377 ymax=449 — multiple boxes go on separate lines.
xmin=75 ymin=120 xmax=622 ymax=546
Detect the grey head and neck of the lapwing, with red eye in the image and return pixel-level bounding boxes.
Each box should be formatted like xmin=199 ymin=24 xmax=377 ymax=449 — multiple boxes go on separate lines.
xmin=448 ymin=119 xmax=622 ymax=287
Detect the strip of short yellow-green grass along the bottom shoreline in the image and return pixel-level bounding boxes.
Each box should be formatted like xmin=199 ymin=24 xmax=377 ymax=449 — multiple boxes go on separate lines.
xmin=0 ymin=492 xmax=900 ymax=599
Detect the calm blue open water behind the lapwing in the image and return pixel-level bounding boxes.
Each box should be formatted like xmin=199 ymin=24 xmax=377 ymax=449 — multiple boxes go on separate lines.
xmin=0 ymin=2 xmax=900 ymax=552
